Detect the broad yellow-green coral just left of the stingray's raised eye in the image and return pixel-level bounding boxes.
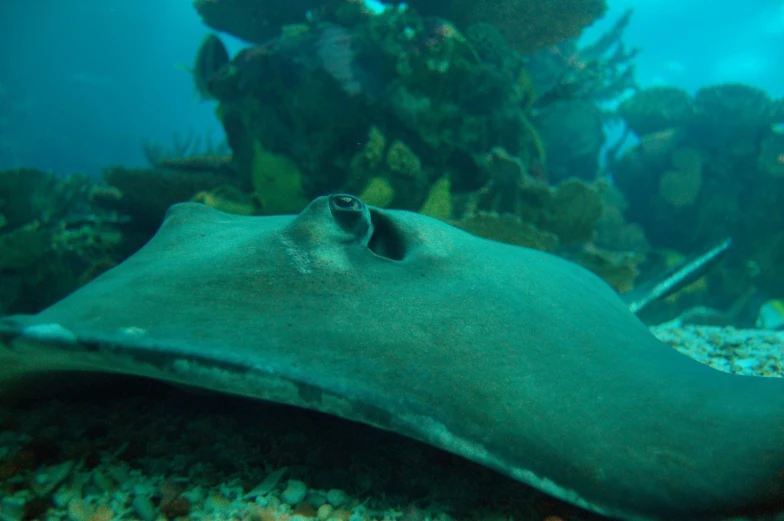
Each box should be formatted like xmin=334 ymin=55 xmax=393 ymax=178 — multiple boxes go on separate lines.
xmin=251 ymin=141 xmax=308 ymax=215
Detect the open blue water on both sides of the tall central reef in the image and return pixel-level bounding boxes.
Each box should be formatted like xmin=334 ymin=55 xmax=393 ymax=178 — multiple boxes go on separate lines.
xmin=0 ymin=0 xmax=784 ymax=174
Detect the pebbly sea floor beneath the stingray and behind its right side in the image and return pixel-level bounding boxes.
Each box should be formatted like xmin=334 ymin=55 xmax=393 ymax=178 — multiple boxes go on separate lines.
xmin=0 ymin=324 xmax=784 ymax=521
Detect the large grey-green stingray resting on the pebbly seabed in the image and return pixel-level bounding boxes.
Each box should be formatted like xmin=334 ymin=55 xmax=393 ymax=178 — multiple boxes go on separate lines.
xmin=0 ymin=194 xmax=784 ymax=520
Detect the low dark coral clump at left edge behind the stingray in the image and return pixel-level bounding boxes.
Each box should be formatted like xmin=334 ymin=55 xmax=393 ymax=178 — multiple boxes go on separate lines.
xmin=0 ymin=169 xmax=130 ymax=314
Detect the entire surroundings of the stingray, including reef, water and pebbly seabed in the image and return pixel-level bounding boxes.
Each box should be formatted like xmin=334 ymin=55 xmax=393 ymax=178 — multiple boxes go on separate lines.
xmin=0 ymin=0 xmax=784 ymax=521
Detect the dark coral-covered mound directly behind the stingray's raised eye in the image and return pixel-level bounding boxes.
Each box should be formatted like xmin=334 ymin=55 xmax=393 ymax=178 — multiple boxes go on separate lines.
xmin=208 ymin=10 xmax=544 ymax=210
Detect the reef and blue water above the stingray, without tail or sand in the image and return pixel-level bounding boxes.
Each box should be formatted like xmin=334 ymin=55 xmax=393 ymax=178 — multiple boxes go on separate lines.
xmin=0 ymin=0 xmax=784 ymax=327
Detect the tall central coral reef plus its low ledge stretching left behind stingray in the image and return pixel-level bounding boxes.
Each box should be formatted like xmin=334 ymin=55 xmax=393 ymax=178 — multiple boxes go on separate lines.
xmin=0 ymin=0 xmax=644 ymax=311
